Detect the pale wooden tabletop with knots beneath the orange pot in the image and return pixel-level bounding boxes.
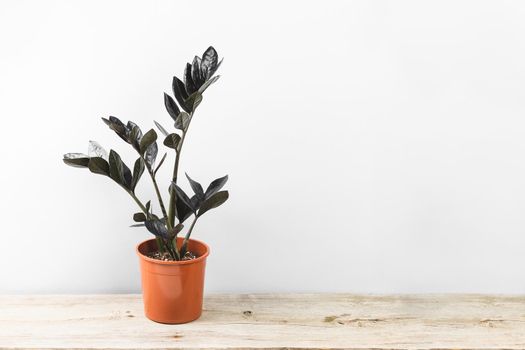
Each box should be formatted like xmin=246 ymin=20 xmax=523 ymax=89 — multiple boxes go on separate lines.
xmin=0 ymin=294 xmax=525 ymax=350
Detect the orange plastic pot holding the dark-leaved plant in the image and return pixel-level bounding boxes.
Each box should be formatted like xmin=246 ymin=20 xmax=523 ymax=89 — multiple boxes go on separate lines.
xmin=137 ymin=238 xmax=210 ymax=324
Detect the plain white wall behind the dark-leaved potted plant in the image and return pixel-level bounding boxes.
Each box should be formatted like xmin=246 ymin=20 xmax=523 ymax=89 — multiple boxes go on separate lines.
xmin=0 ymin=0 xmax=525 ymax=293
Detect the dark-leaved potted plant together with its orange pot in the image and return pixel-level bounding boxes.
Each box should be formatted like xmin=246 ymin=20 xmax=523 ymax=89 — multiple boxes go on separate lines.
xmin=64 ymin=47 xmax=228 ymax=323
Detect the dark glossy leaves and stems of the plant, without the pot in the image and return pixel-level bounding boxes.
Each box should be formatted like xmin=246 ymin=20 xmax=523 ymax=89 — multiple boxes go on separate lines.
xmin=64 ymin=47 xmax=228 ymax=260
